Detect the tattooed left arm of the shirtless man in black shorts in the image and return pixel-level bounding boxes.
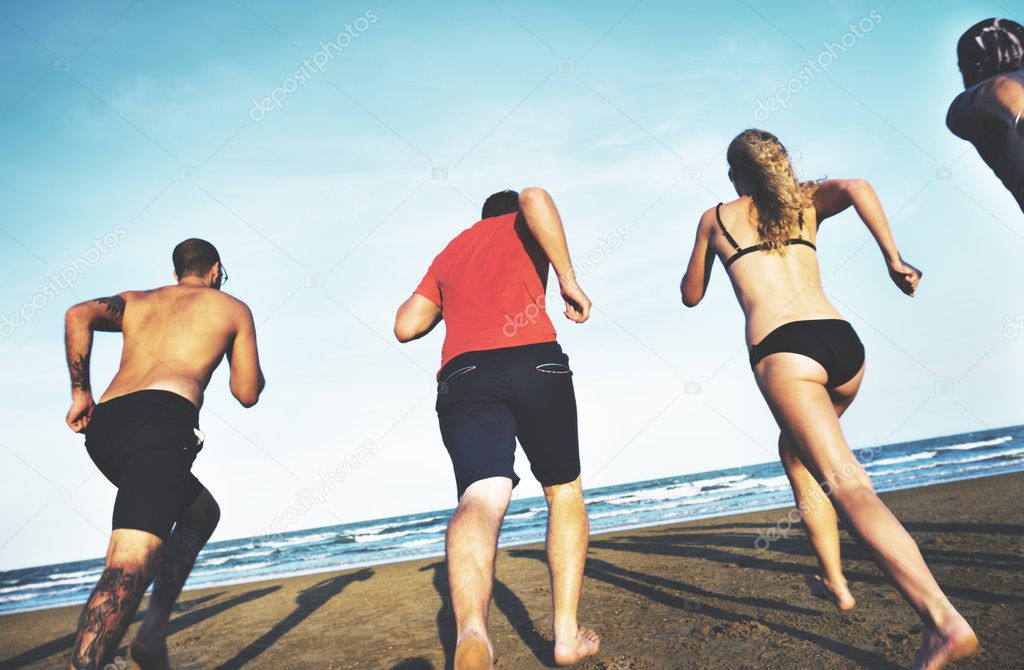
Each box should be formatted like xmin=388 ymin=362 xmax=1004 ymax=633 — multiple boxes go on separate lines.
xmin=65 ymin=293 xmax=127 ymax=432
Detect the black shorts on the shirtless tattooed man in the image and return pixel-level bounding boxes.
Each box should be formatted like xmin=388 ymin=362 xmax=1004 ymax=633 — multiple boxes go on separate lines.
xmin=85 ymin=390 xmax=203 ymax=540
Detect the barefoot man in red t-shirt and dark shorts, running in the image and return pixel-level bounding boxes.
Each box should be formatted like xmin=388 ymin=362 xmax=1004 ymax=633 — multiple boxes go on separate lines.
xmin=394 ymin=189 xmax=600 ymax=670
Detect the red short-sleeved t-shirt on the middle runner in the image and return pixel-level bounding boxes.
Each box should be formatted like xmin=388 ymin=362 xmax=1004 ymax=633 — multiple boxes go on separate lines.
xmin=416 ymin=213 xmax=557 ymax=368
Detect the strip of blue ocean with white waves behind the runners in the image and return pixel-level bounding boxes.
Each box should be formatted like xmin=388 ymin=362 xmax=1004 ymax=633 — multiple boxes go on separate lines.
xmin=0 ymin=425 xmax=1024 ymax=615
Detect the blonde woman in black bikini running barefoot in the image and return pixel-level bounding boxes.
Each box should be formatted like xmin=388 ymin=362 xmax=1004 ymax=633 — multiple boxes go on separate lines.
xmin=680 ymin=130 xmax=978 ymax=669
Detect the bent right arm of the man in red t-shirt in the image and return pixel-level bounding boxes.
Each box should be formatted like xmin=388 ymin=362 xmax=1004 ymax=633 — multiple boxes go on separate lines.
xmin=519 ymin=186 xmax=591 ymax=324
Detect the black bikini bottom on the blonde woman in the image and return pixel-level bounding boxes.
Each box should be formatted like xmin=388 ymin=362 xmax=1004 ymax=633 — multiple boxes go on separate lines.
xmin=751 ymin=319 xmax=864 ymax=388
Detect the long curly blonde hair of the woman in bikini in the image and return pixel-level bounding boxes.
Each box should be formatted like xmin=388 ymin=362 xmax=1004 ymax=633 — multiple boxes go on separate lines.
xmin=726 ymin=128 xmax=817 ymax=251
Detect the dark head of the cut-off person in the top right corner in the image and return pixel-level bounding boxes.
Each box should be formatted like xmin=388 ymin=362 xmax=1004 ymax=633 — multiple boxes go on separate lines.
xmin=956 ymin=18 xmax=1024 ymax=88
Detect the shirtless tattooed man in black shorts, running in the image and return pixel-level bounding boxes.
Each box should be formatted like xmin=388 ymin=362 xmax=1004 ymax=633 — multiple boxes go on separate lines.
xmin=65 ymin=239 xmax=264 ymax=669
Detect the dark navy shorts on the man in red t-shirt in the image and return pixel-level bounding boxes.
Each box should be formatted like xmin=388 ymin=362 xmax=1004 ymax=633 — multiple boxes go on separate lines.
xmin=436 ymin=342 xmax=580 ymax=498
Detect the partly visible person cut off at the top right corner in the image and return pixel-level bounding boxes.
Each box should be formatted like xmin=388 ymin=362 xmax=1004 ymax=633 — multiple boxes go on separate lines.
xmin=946 ymin=18 xmax=1024 ymax=211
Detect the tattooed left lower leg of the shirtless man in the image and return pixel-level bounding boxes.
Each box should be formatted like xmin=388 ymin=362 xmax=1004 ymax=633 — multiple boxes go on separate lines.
xmin=71 ymin=568 xmax=148 ymax=670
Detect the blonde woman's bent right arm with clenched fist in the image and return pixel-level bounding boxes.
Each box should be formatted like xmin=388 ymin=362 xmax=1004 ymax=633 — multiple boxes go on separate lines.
xmin=814 ymin=179 xmax=922 ymax=297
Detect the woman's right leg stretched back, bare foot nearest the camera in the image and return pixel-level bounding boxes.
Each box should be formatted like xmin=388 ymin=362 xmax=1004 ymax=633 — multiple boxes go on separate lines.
xmin=757 ymin=353 xmax=977 ymax=668
